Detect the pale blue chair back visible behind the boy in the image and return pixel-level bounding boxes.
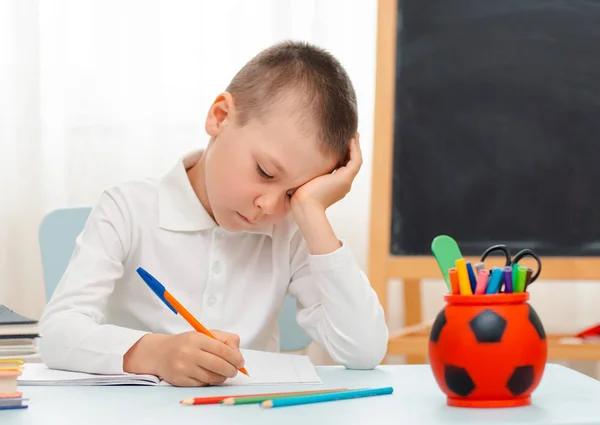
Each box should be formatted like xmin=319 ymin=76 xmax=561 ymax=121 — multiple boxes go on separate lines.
xmin=39 ymin=207 xmax=311 ymax=351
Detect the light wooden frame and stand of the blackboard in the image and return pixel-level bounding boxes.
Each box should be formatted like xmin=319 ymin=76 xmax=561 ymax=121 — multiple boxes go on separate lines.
xmin=368 ymin=0 xmax=600 ymax=363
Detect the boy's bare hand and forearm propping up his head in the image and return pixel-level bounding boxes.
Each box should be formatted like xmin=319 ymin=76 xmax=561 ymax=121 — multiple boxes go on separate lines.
xmin=291 ymin=134 xmax=362 ymax=255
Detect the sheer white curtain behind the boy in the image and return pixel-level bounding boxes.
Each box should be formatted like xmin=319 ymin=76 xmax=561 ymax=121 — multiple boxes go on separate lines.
xmin=0 ymin=0 xmax=377 ymax=317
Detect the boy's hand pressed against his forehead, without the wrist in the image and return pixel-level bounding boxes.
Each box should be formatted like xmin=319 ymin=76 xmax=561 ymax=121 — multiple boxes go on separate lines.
xmin=291 ymin=134 xmax=362 ymax=216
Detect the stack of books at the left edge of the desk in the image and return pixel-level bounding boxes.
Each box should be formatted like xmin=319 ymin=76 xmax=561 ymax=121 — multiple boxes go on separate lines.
xmin=0 ymin=305 xmax=39 ymax=410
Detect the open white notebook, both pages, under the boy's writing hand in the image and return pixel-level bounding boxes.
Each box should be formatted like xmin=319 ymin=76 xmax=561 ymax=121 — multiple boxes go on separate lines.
xmin=18 ymin=349 xmax=322 ymax=386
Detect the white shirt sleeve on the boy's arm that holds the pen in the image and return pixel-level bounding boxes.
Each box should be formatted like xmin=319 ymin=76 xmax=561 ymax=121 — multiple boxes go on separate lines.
xmin=39 ymin=191 xmax=146 ymax=373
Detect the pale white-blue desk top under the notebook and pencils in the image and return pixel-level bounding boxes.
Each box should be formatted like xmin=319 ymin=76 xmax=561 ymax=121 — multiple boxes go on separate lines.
xmin=0 ymin=365 xmax=600 ymax=425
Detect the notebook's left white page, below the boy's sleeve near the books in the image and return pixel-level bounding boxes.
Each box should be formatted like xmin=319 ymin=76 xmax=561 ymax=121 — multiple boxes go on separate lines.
xmin=18 ymin=363 xmax=159 ymax=385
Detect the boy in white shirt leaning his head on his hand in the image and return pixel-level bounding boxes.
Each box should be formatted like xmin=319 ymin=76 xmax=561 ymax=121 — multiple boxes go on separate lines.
xmin=40 ymin=42 xmax=388 ymax=386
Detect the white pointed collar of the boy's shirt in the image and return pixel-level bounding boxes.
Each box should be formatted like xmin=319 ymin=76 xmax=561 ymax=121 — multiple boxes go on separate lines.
xmin=158 ymin=150 xmax=273 ymax=237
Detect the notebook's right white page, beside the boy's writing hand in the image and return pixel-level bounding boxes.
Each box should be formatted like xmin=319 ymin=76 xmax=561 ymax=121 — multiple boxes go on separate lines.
xmin=221 ymin=349 xmax=322 ymax=385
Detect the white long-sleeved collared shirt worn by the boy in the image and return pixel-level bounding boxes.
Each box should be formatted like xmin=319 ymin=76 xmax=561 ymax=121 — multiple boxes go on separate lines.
xmin=39 ymin=151 xmax=388 ymax=373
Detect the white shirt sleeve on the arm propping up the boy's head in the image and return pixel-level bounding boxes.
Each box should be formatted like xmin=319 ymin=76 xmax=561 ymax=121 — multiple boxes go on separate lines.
xmin=288 ymin=232 xmax=389 ymax=369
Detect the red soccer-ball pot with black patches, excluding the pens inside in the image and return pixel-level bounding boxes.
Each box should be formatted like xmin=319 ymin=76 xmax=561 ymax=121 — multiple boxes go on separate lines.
xmin=428 ymin=292 xmax=548 ymax=407
